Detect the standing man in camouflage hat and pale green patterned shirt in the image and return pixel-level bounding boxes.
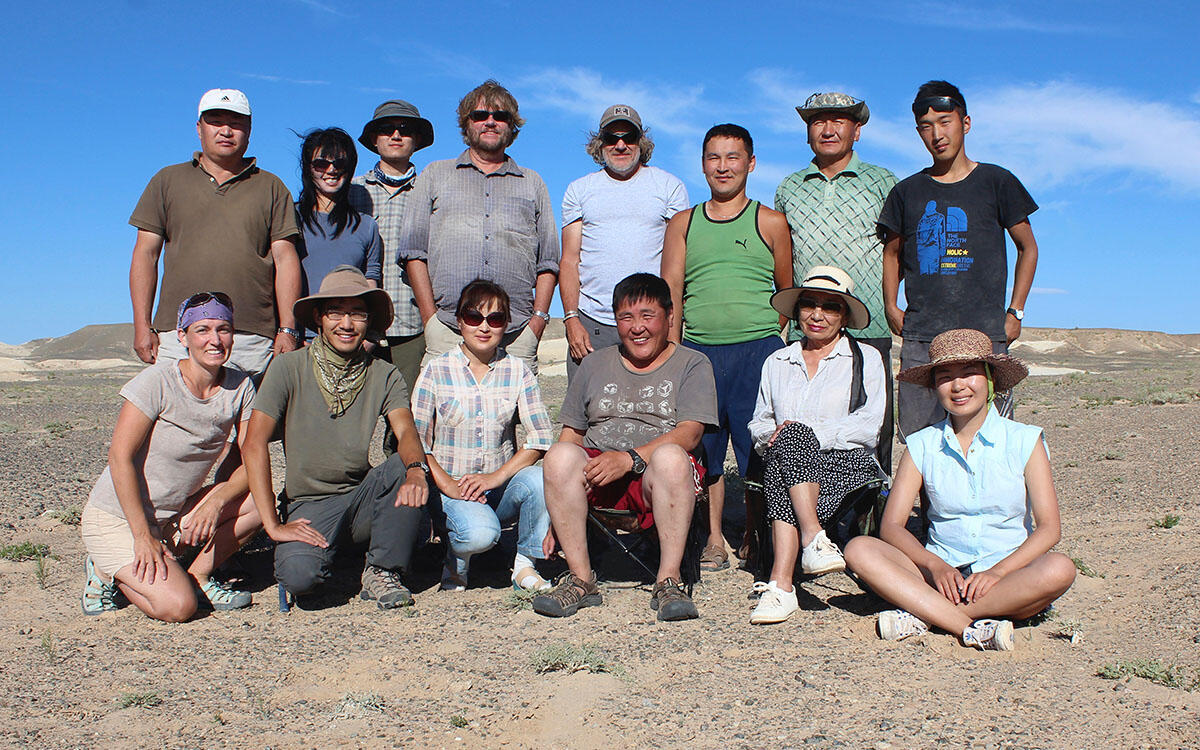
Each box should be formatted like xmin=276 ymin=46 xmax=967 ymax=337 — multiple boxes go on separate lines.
xmin=775 ymin=92 xmax=896 ymax=474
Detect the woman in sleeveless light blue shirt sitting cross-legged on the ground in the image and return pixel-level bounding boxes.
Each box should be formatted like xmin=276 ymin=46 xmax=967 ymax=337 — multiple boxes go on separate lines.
xmin=846 ymin=329 xmax=1075 ymax=650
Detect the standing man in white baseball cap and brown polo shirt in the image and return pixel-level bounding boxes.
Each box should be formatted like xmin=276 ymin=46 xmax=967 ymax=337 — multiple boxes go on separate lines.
xmin=130 ymin=89 xmax=300 ymax=376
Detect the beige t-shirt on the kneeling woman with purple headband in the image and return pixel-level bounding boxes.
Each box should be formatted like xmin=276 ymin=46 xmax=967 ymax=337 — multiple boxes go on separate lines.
xmin=88 ymin=360 xmax=254 ymax=522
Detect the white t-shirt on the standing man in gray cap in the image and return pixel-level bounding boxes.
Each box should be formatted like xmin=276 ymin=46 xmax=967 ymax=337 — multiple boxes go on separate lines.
xmin=563 ymin=167 xmax=689 ymax=325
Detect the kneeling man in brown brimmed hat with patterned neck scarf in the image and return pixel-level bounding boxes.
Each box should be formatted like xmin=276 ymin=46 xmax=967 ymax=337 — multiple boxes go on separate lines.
xmin=244 ymin=265 xmax=430 ymax=610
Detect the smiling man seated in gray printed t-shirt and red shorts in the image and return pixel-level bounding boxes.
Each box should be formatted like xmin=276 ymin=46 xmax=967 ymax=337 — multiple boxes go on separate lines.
xmin=533 ymin=274 xmax=716 ymax=620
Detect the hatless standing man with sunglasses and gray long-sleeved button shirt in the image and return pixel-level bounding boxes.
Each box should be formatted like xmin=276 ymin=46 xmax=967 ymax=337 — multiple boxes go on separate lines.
xmin=400 ymin=80 xmax=559 ymax=374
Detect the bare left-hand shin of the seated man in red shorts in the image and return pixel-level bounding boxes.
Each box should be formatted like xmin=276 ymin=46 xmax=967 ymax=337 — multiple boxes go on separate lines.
xmin=542 ymin=443 xmax=592 ymax=581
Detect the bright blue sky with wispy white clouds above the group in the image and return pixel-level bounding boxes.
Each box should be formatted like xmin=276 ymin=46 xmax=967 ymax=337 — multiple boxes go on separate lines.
xmin=0 ymin=0 xmax=1200 ymax=343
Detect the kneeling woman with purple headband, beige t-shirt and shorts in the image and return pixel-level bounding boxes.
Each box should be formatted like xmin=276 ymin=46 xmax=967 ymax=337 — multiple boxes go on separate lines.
xmin=79 ymin=292 xmax=262 ymax=622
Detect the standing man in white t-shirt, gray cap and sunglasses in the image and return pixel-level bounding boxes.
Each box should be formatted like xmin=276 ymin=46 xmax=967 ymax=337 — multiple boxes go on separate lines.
xmin=558 ymin=104 xmax=688 ymax=378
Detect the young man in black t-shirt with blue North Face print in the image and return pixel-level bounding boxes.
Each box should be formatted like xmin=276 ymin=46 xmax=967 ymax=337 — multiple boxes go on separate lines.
xmin=878 ymin=80 xmax=1038 ymax=437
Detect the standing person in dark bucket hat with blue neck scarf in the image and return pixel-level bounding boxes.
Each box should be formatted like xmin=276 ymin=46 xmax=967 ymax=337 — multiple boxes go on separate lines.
xmin=349 ymin=100 xmax=433 ymax=441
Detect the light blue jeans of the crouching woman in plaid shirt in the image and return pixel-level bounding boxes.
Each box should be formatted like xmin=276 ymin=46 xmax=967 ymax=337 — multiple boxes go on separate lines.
xmin=442 ymin=466 xmax=550 ymax=577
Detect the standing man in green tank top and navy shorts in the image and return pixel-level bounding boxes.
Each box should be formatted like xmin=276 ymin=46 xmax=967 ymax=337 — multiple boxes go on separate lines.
xmin=662 ymin=124 xmax=792 ymax=570
